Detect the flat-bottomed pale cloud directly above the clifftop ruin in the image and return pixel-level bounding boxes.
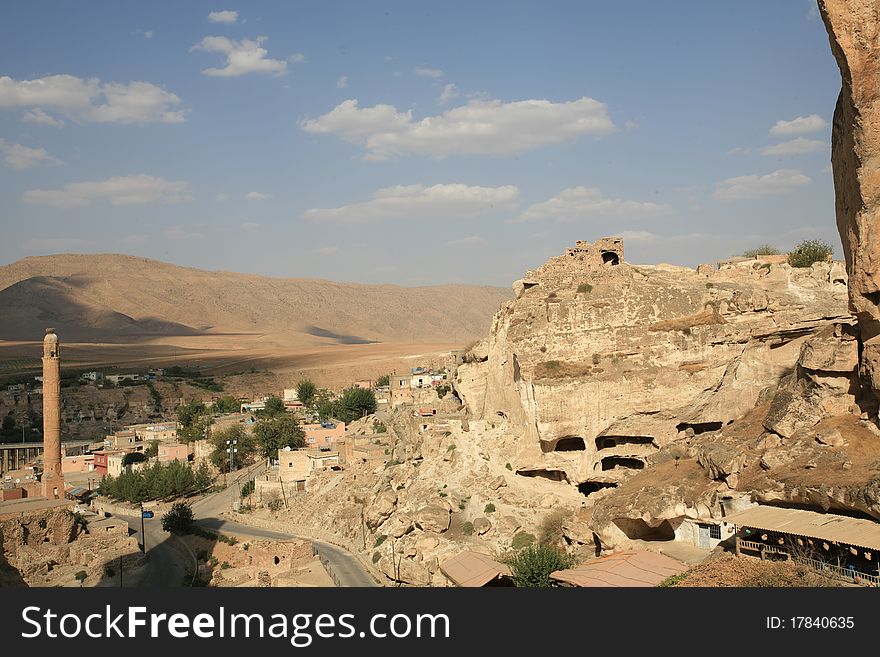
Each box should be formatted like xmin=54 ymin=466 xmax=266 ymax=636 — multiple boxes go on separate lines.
xmin=511 ymin=186 xmax=672 ymax=223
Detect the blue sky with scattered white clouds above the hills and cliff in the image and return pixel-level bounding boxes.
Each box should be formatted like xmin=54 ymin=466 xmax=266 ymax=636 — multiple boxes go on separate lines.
xmin=0 ymin=0 xmax=841 ymax=286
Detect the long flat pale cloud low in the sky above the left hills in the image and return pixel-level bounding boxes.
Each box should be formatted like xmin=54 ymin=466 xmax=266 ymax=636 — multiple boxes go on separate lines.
xmin=22 ymin=175 xmax=192 ymax=208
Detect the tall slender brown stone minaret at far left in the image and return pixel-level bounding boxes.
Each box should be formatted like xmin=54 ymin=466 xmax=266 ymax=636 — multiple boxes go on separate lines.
xmin=41 ymin=329 xmax=64 ymax=500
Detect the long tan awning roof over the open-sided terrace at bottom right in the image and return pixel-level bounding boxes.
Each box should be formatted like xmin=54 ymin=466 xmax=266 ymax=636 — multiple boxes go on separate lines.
xmin=723 ymin=506 xmax=880 ymax=550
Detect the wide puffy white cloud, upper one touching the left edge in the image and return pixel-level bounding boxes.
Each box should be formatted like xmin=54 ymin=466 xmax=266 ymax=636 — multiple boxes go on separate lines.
xmin=0 ymin=75 xmax=184 ymax=125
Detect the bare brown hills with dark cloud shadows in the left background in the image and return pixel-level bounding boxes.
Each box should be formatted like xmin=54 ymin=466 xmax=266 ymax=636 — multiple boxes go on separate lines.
xmin=0 ymin=254 xmax=512 ymax=346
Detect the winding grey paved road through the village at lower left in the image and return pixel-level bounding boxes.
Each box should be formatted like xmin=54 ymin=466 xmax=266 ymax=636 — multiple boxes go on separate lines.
xmin=112 ymin=463 xmax=377 ymax=587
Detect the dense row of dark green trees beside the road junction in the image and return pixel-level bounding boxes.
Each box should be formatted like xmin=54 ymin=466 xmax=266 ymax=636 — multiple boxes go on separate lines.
xmin=98 ymin=461 xmax=213 ymax=504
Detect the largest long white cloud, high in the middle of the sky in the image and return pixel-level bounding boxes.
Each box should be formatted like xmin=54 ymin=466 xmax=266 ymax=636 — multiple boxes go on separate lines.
xmin=300 ymin=97 xmax=615 ymax=160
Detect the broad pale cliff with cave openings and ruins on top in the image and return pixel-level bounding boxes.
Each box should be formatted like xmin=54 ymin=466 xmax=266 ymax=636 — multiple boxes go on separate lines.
xmin=455 ymin=240 xmax=855 ymax=494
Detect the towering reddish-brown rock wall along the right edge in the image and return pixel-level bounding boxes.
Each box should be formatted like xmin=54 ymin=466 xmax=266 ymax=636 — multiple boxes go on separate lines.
xmin=819 ymin=0 xmax=880 ymax=397
